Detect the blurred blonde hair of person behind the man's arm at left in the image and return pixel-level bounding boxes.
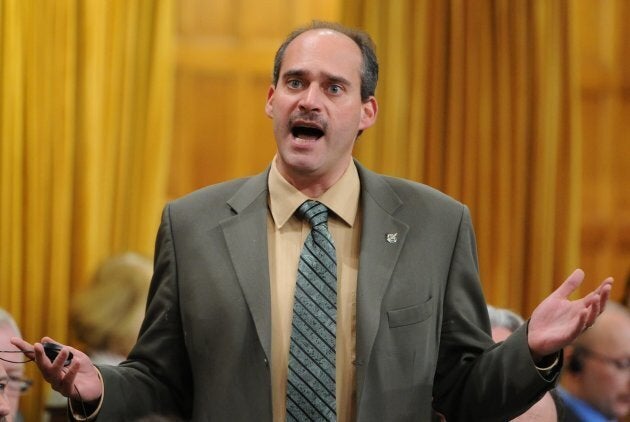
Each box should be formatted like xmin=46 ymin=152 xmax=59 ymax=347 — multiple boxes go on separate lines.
xmin=70 ymin=252 xmax=153 ymax=364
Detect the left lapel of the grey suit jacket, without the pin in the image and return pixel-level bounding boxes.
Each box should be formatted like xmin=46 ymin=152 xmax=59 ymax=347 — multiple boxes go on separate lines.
xmin=221 ymin=171 xmax=271 ymax=359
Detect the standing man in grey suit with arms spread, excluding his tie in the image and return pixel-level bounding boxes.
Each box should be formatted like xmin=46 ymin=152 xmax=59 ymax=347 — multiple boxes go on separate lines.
xmin=15 ymin=23 xmax=612 ymax=421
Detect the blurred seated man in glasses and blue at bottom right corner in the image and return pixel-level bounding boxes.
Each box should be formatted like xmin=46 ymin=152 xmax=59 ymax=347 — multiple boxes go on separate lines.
xmin=559 ymin=302 xmax=630 ymax=422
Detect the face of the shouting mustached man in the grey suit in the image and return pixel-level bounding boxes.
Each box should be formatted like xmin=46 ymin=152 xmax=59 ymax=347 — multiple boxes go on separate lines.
xmin=265 ymin=29 xmax=377 ymax=194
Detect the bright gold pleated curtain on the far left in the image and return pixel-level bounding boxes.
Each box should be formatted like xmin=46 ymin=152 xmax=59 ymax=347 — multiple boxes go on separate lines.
xmin=0 ymin=0 xmax=174 ymax=421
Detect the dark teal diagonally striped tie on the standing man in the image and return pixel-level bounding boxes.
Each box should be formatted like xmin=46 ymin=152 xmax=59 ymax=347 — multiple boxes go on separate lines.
xmin=287 ymin=201 xmax=337 ymax=421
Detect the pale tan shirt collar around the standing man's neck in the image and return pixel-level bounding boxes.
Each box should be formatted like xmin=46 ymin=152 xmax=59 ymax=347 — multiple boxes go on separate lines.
xmin=267 ymin=157 xmax=361 ymax=228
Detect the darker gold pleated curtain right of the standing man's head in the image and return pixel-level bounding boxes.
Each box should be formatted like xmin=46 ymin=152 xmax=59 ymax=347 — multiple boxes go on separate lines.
xmin=344 ymin=0 xmax=581 ymax=315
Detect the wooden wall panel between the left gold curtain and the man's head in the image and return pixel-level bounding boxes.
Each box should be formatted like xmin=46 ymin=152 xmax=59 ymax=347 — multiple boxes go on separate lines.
xmin=168 ymin=0 xmax=341 ymax=198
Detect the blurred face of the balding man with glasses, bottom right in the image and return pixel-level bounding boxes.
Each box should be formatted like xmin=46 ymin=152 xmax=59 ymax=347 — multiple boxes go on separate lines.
xmin=578 ymin=315 xmax=630 ymax=419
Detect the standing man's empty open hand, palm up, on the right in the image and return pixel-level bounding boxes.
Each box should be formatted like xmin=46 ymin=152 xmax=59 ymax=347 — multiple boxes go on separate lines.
xmin=527 ymin=269 xmax=613 ymax=362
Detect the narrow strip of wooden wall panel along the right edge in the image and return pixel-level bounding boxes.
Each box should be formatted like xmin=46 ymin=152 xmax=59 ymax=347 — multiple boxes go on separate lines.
xmin=574 ymin=0 xmax=630 ymax=299
